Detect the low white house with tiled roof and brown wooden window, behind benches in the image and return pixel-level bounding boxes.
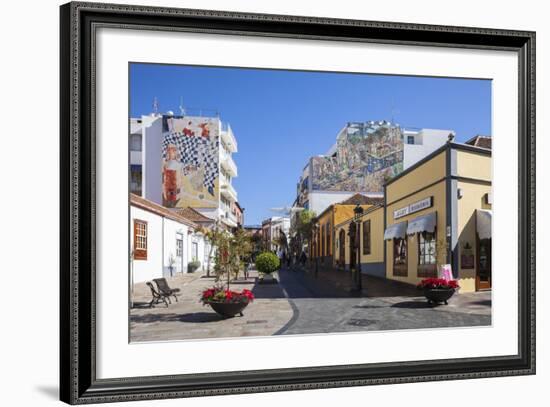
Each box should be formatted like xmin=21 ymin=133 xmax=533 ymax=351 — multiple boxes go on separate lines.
xmin=130 ymin=194 xmax=209 ymax=285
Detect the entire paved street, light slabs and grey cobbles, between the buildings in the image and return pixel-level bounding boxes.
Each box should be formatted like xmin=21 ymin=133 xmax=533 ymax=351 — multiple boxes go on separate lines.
xmin=130 ymin=269 xmax=491 ymax=341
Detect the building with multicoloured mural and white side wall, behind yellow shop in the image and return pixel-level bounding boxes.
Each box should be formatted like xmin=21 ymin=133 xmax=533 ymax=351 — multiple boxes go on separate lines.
xmin=295 ymin=121 xmax=454 ymax=214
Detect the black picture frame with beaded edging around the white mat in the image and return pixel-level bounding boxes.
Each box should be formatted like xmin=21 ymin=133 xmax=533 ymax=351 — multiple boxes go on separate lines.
xmin=60 ymin=2 xmax=535 ymax=404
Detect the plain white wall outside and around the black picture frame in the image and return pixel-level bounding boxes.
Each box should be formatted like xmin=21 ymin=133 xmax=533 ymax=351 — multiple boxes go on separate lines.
xmin=0 ymin=0 xmax=550 ymax=407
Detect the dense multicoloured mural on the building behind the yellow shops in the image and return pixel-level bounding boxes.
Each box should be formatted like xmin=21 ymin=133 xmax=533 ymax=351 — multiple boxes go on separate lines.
xmin=310 ymin=122 xmax=403 ymax=192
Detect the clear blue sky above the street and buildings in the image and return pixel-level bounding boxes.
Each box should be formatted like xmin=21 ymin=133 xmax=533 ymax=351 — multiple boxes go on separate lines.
xmin=130 ymin=64 xmax=491 ymax=225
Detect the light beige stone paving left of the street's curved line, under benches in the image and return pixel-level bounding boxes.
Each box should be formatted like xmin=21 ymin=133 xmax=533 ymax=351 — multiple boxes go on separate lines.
xmin=130 ymin=272 xmax=293 ymax=342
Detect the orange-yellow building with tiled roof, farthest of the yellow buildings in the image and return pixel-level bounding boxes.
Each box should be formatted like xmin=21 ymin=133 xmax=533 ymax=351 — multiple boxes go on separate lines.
xmin=310 ymin=194 xmax=383 ymax=269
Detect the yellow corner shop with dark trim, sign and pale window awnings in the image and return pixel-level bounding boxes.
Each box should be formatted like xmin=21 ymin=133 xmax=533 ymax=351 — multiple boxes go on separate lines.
xmin=383 ymin=142 xmax=492 ymax=292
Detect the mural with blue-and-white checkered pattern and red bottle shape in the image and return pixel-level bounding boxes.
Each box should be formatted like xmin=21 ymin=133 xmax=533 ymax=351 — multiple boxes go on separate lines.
xmin=162 ymin=117 xmax=219 ymax=208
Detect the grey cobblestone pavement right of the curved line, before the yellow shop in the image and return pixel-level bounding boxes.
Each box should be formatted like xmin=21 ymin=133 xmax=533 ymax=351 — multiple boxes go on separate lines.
xmin=277 ymin=270 xmax=491 ymax=335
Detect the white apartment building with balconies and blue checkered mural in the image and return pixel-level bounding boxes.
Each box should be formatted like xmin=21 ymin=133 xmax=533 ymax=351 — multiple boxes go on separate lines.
xmin=129 ymin=112 xmax=242 ymax=228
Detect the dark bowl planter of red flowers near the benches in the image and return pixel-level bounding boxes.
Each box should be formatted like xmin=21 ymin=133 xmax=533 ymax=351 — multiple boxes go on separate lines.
xmin=201 ymin=287 xmax=254 ymax=318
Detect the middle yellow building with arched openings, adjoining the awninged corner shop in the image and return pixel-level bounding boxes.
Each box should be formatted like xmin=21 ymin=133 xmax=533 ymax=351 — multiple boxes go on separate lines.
xmin=334 ymin=204 xmax=386 ymax=277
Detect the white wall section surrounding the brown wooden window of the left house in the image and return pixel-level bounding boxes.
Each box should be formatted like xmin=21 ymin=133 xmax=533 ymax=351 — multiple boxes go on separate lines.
xmin=130 ymin=206 xmax=163 ymax=283
